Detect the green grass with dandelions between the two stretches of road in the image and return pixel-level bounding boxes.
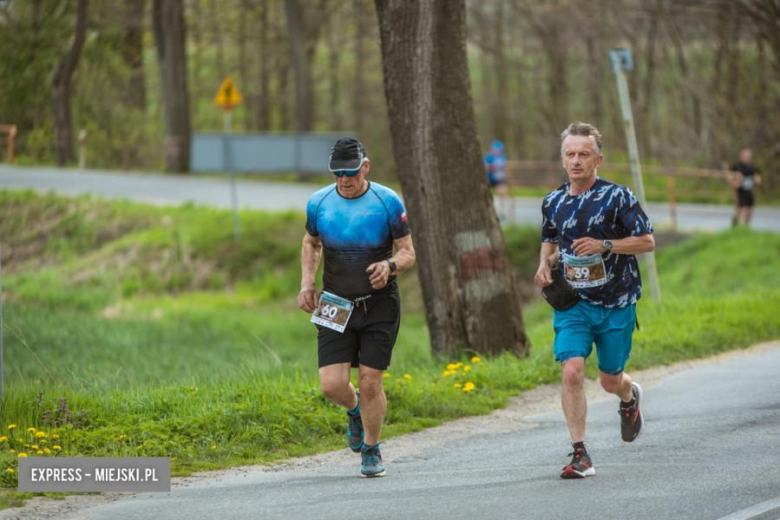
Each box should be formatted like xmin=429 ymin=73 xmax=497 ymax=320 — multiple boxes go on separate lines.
xmin=0 ymin=193 xmax=780 ymax=504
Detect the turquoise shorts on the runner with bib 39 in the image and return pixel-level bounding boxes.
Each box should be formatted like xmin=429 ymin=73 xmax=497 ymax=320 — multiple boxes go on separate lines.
xmin=553 ymin=300 xmax=636 ymax=375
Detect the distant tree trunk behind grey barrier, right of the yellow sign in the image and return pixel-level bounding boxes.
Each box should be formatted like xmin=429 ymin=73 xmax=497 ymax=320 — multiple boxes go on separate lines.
xmin=284 ymin=0 xmax=314 ymax=132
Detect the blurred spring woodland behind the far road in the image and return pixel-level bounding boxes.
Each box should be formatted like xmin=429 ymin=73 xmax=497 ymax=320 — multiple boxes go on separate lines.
xmin=0 ymin=0 xmax=780 ymax=200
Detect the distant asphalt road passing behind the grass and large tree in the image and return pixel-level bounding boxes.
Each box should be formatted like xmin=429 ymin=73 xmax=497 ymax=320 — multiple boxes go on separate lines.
xmin=0 ymin=165 xmax=780 ymax=233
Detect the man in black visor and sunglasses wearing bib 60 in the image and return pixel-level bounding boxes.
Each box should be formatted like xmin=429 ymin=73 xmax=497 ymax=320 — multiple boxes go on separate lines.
xmin=298 ymin=138 xmax=415 ymax=477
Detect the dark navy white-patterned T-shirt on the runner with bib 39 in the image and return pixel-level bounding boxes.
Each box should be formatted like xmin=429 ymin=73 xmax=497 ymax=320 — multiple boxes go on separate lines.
xmin=542 ymin=177 xmax=653 ymax=307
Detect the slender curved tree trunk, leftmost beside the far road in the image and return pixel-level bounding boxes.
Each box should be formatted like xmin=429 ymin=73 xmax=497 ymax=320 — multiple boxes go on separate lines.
xmin=51 ymin=0 xmax=87 ymax=166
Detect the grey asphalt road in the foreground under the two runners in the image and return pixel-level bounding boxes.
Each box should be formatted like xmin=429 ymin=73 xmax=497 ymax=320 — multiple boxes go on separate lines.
xmin=62 ymin=343 xmax=780 ymax=520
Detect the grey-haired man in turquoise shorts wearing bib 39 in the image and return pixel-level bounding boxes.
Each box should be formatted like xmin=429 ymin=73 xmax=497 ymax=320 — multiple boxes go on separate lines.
xmin=535 ymin=123 xmax=655 ymax=478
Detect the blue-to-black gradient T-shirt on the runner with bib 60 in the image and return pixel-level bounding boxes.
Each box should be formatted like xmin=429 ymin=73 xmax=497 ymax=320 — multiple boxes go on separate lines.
xmin=306 ymin=182 xmax=411 ymax=298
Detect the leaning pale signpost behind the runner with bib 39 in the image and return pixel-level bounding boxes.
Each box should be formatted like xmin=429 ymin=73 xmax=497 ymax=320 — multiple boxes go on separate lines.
xmin=609 ymin=48 xmax=661 ymax=302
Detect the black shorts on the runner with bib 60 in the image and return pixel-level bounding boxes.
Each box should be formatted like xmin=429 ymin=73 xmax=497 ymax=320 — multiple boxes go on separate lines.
xmin=317 ymin=283 xmax=401 ymax=370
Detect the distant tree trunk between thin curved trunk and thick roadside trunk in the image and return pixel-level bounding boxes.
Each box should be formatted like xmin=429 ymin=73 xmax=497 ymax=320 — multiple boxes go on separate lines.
xmin=120 ymin=0 xmax=146 ymax=112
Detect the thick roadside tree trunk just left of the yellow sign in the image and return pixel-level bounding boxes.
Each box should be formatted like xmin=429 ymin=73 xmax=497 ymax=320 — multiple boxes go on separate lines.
xmin=152 ymin=0 xmax=191 ymax=173
